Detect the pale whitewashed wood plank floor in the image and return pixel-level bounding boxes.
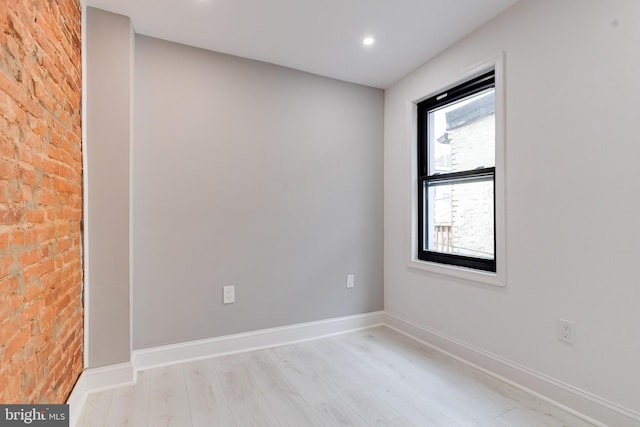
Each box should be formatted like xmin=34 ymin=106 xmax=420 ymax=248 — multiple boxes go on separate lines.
xmin=78 ymin=327 xmax=591 ymax=427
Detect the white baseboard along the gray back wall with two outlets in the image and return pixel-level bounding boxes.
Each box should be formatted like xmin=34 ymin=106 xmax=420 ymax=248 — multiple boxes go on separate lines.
xmin=132 ymin=311 xmax=383 ymax=372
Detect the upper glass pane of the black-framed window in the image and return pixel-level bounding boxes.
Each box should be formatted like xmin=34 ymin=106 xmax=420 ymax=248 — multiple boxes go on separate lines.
xmin=428 ymin=88 xmax=496 ymax=175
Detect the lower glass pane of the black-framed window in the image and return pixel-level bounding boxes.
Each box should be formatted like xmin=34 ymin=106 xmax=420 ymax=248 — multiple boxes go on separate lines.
xmin=423 ymin=180 xmax=495 ymax=259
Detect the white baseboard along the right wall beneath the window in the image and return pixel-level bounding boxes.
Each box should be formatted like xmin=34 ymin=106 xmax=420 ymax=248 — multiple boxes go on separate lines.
xmin=384 ymin=312 xmax=640 ymax=427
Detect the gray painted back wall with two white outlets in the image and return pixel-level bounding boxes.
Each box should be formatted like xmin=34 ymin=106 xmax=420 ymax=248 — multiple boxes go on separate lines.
xmin=133 ymin=36 xmax=384 ymax=349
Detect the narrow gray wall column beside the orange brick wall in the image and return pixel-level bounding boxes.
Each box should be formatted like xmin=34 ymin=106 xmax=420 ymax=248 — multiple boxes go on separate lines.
xmin=84 ymin=7 xmax=134 ymax=368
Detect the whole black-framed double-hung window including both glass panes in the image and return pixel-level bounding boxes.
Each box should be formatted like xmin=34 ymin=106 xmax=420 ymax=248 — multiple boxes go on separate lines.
xmin=416 ymin=70 xmax=496 ymax=272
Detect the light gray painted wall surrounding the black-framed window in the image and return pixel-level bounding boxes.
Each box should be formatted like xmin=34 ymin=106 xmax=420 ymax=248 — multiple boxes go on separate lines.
xmin=384 ymin=0 xmax=640 ymax=418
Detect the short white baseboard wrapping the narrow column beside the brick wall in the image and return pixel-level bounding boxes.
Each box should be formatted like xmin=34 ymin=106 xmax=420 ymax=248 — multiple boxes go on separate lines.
xmin=67 ymin=362 xmax=135 ymax=427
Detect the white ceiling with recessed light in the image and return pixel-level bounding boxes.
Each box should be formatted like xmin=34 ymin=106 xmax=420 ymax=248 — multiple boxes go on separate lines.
xmin=85 ymin=0 xmax=517 ymax=88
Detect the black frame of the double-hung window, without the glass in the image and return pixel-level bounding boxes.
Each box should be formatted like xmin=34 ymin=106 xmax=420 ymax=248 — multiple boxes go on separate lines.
xmin=417 ymin=69 xmax=497 ymax=273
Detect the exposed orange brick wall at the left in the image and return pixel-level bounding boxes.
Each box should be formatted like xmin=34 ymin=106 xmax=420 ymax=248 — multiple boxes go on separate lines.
xmin=0 ymin=0 xmax=83 ymax=403
